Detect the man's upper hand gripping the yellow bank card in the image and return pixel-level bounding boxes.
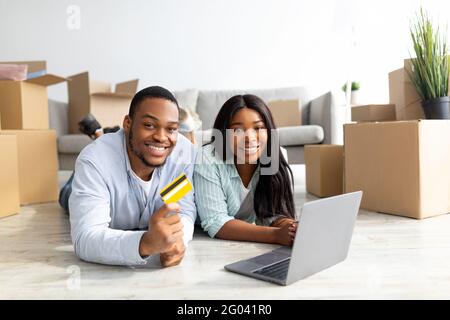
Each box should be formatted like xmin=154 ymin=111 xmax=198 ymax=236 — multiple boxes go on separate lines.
xmin=139 ymin=203 xmax=184 ymax=257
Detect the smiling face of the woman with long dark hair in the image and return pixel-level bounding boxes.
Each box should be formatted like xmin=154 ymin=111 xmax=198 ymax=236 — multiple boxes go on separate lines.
xmin=229 ymin=108 xmax=268 ymax=164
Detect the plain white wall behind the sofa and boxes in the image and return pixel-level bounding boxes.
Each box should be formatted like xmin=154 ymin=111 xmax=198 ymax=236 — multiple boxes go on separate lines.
xmin=0 ymin=0 xmax=450 ymax=103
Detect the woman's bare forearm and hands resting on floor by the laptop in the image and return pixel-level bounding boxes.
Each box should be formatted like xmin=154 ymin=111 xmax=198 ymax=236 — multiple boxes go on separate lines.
xmin=216 ymin=219 xmax=293 ymax=246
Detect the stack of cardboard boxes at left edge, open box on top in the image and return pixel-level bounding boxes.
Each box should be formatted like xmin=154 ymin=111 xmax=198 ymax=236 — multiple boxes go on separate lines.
xmin=0 ymin=61 xmax=60 ymax=217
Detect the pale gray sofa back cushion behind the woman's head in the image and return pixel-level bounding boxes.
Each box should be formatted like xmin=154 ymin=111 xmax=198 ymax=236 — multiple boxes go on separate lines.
xmin=196 ymin=87 xmax=311 ymax=129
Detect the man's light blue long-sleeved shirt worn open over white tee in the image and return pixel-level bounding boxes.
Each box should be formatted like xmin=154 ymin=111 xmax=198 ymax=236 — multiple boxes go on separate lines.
xmin=69 ymin=130 xmax=196 ymax=265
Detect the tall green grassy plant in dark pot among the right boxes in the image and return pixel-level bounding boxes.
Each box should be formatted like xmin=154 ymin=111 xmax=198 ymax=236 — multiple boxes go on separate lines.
xmin=407 ymin=9 xmax=450 ymax=119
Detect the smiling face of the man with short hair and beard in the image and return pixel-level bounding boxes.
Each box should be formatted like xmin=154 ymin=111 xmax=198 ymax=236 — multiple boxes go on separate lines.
xmin=123 ymin=98 xmax=179 ymax=167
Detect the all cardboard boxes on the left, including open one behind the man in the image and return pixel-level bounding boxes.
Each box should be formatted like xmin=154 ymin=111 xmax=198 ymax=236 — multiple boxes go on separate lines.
xmin=0 ymin=61 xmax=138 ymax=217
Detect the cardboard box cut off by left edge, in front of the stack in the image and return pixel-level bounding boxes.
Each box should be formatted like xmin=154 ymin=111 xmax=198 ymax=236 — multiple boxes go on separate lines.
xmin=0 ymin=135 xmax=20 ymax=218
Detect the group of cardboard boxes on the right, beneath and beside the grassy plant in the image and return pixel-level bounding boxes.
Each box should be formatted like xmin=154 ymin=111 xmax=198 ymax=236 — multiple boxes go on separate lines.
xmin=305 ymin=60 xmax=450 ymax=219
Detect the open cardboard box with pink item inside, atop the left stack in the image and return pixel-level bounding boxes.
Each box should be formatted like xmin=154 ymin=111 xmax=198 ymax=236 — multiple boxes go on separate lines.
xmin=0 ymin=61 xmax=66 ymax=129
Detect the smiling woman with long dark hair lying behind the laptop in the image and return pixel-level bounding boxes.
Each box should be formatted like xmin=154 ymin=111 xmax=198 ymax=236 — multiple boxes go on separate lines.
xmin=194 ymin=95 xmax=297 ymax=246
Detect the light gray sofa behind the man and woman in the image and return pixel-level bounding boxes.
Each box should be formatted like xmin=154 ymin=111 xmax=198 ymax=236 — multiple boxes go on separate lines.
xmin=49 ymin=87 xmax=342 ymax=170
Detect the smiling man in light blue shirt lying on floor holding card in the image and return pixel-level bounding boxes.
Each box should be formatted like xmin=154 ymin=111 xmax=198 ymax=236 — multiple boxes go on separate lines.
xmin=69 ymin=87 xmax=196 ymax=267
